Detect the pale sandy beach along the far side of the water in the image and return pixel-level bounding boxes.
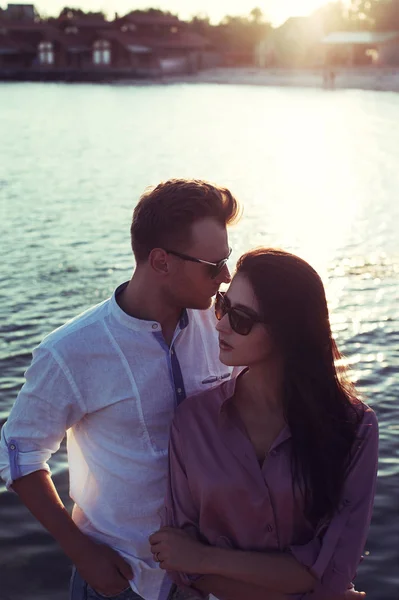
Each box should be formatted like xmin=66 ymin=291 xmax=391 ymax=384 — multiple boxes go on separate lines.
xmin=154 ymin=67 xmax=399 ymax=92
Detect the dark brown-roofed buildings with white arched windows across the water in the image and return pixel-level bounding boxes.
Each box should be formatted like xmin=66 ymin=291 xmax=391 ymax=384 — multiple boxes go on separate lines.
xmin=0 ymin=5 xmax=216 ymax=80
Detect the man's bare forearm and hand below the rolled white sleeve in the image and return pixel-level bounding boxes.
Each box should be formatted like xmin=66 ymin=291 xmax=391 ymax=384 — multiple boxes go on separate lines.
xmin=12 ymin=471 xmax=133 ymax=596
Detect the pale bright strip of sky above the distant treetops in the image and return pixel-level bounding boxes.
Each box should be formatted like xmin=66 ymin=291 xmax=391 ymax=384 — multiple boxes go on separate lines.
xmin=28 ymin=0 xmax=334 ymax=25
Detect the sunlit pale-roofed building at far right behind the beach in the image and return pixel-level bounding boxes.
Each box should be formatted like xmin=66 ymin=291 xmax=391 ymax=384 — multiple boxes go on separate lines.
xmin=321 ymin=31 xmax=399 ymax=67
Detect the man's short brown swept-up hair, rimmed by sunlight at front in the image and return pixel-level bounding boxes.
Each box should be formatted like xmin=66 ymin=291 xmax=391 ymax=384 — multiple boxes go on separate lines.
xmin=130 ymin=179 xmax=240 ymax=263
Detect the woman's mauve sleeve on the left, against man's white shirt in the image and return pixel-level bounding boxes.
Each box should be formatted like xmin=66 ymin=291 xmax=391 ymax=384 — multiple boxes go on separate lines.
xmin=162 ymin=418 xmax=207 ymax=598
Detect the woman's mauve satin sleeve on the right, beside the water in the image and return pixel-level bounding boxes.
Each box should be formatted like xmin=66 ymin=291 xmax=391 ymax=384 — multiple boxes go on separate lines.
xmin=289 ymin=408 xmax=378 ymax=600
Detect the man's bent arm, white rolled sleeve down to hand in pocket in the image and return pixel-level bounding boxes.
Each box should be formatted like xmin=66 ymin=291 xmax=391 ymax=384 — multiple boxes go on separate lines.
xmin=0 ymin=347 xmax=131 ymax=595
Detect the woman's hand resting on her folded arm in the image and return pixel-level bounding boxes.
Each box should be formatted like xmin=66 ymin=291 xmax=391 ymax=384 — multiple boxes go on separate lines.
xmin=149 ymin=527 xmax=206 ymax=573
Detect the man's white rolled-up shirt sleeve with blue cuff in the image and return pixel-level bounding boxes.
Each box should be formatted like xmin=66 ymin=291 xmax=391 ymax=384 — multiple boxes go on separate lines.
xmin=0 ymin=346 xmax=86 ymax=488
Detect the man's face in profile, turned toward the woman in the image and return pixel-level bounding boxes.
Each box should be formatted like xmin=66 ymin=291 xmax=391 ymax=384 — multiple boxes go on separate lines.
xmin=168 ymin=218 xmax=231 ymax=309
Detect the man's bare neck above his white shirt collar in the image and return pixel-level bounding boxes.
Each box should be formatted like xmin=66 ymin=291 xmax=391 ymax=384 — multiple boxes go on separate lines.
xmin=117 ymin=270 xmax=181 ymax=345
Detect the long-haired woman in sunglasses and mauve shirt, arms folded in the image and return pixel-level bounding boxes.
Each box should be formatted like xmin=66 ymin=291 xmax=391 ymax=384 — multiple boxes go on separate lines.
xmin=150 ymin=249 xmax=378 ymax=600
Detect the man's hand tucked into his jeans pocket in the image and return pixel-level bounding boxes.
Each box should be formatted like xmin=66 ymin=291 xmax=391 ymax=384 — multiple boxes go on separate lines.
xmin=74 ymin=540 xmax=133 ymax=596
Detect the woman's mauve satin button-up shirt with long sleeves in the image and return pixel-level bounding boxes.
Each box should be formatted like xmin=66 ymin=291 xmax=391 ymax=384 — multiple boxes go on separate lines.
xmin=164 ymin=379 xmax=378 ymax=600
